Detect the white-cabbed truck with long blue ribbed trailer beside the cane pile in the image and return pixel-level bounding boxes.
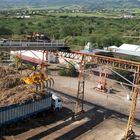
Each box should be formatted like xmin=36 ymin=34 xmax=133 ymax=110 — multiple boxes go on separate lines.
xmin=0 ymin=92 xmax=62 ymax=127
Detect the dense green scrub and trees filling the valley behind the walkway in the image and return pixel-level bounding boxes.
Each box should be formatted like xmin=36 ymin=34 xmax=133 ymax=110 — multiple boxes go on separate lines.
xmin=0 ymin=11 xmax=140 ymax=50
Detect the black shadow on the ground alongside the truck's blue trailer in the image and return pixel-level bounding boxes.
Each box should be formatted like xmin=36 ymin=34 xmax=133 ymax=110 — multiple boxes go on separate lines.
xmin=0 ymin=107 xmax=73 ymax=137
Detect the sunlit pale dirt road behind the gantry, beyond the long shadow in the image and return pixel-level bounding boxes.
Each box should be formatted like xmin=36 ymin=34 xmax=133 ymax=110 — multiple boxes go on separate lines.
xmin=53 ymin=76 xmax=140 ymax=119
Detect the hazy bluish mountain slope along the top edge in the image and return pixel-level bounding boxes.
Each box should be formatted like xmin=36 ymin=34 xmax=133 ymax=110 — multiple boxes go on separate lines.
xmin=0 ymin=0 xmax=140 ymax=9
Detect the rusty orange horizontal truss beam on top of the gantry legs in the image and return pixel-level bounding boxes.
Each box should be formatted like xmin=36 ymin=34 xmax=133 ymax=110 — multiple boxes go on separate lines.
xmin=58 ymin=52 xmax=140 ymax=72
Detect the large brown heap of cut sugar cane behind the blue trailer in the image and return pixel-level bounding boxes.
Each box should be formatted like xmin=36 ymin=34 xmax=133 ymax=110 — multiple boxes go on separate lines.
xmin=0 ymin=66 xmax=47 ymax=107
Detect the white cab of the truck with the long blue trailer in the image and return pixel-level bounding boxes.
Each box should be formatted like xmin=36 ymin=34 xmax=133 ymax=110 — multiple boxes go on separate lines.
xmin=52 ymin=94 xmax=62 ymax=111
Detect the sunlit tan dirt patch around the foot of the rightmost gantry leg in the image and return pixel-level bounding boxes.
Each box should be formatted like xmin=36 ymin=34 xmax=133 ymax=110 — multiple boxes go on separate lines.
xmin=76 ymin=118 xmax=140 ymax=140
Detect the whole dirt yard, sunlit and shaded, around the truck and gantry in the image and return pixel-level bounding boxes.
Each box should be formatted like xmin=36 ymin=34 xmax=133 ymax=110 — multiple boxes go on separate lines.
xmin=0 ymin=76 xmax=140 ymax=140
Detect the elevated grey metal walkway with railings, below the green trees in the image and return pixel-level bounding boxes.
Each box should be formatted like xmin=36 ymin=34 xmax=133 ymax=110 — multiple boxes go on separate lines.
xmin=0 ymin=41 xmax=69 ymax=51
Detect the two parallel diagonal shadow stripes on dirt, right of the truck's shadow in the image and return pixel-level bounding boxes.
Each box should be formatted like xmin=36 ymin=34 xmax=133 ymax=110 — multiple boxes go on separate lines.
xmin=28 ymin=107 xmax=105 ymax=140
